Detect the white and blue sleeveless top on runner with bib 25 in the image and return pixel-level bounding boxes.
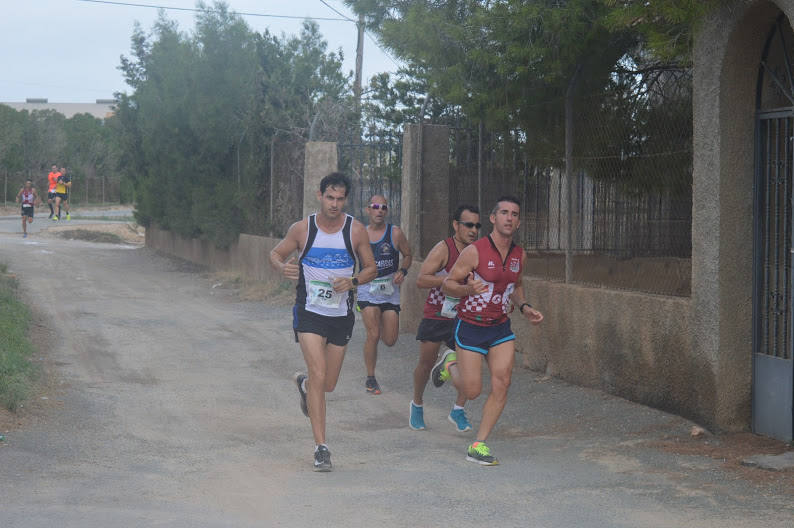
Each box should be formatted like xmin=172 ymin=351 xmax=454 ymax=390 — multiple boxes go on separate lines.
xmin=295 ymin=214 xmax=356 ymax=317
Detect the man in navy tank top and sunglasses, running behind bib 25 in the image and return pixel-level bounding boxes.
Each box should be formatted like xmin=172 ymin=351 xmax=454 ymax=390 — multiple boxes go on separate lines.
xmin=357 ymin=195 xmax=412 ymax=394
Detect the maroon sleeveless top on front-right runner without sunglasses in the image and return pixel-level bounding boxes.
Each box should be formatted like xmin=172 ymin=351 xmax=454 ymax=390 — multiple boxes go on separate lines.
xmin=458 ymin=235 xmax=524 ymax=326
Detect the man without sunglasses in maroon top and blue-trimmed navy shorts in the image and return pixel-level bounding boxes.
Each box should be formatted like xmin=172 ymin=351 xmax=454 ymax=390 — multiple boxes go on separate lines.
xmin=441 ymin=196 xmax=543 ymax=466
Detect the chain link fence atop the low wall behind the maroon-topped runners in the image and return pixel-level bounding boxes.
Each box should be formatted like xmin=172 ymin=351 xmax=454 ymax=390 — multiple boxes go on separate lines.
xmin=449 ymin=71 xmax=692 ymax=296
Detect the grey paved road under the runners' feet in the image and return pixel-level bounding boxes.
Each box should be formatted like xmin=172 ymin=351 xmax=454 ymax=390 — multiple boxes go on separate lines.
xmin=0 ymin=234 xmax=794 ymax=528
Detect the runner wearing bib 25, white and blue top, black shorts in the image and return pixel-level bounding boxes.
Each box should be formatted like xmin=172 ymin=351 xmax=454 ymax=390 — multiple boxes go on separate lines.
xmin=270 ymin=172 xmax=377 ymax=471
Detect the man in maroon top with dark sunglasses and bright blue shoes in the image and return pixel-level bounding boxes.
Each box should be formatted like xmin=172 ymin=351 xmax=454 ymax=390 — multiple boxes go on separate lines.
xmin=408 ymin=205 xmax=480 ymax=433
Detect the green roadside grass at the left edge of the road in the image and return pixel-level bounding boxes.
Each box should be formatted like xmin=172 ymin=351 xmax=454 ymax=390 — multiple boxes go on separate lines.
xmin=0 ymin=263 xmax=39 ymax=412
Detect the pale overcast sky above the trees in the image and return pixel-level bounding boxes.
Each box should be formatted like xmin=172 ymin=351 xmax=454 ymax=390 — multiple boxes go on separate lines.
xmin=0 ymin=0 xmax=397 ymax=102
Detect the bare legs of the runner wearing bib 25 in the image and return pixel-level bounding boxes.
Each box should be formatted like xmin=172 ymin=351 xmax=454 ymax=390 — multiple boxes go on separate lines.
xmin=298 ymin=333 xmax=345 ymax=445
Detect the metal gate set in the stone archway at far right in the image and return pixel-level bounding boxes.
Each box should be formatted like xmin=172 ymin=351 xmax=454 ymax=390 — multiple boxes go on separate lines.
xmin=753 ymin=15 xmax=794 ymax=441
